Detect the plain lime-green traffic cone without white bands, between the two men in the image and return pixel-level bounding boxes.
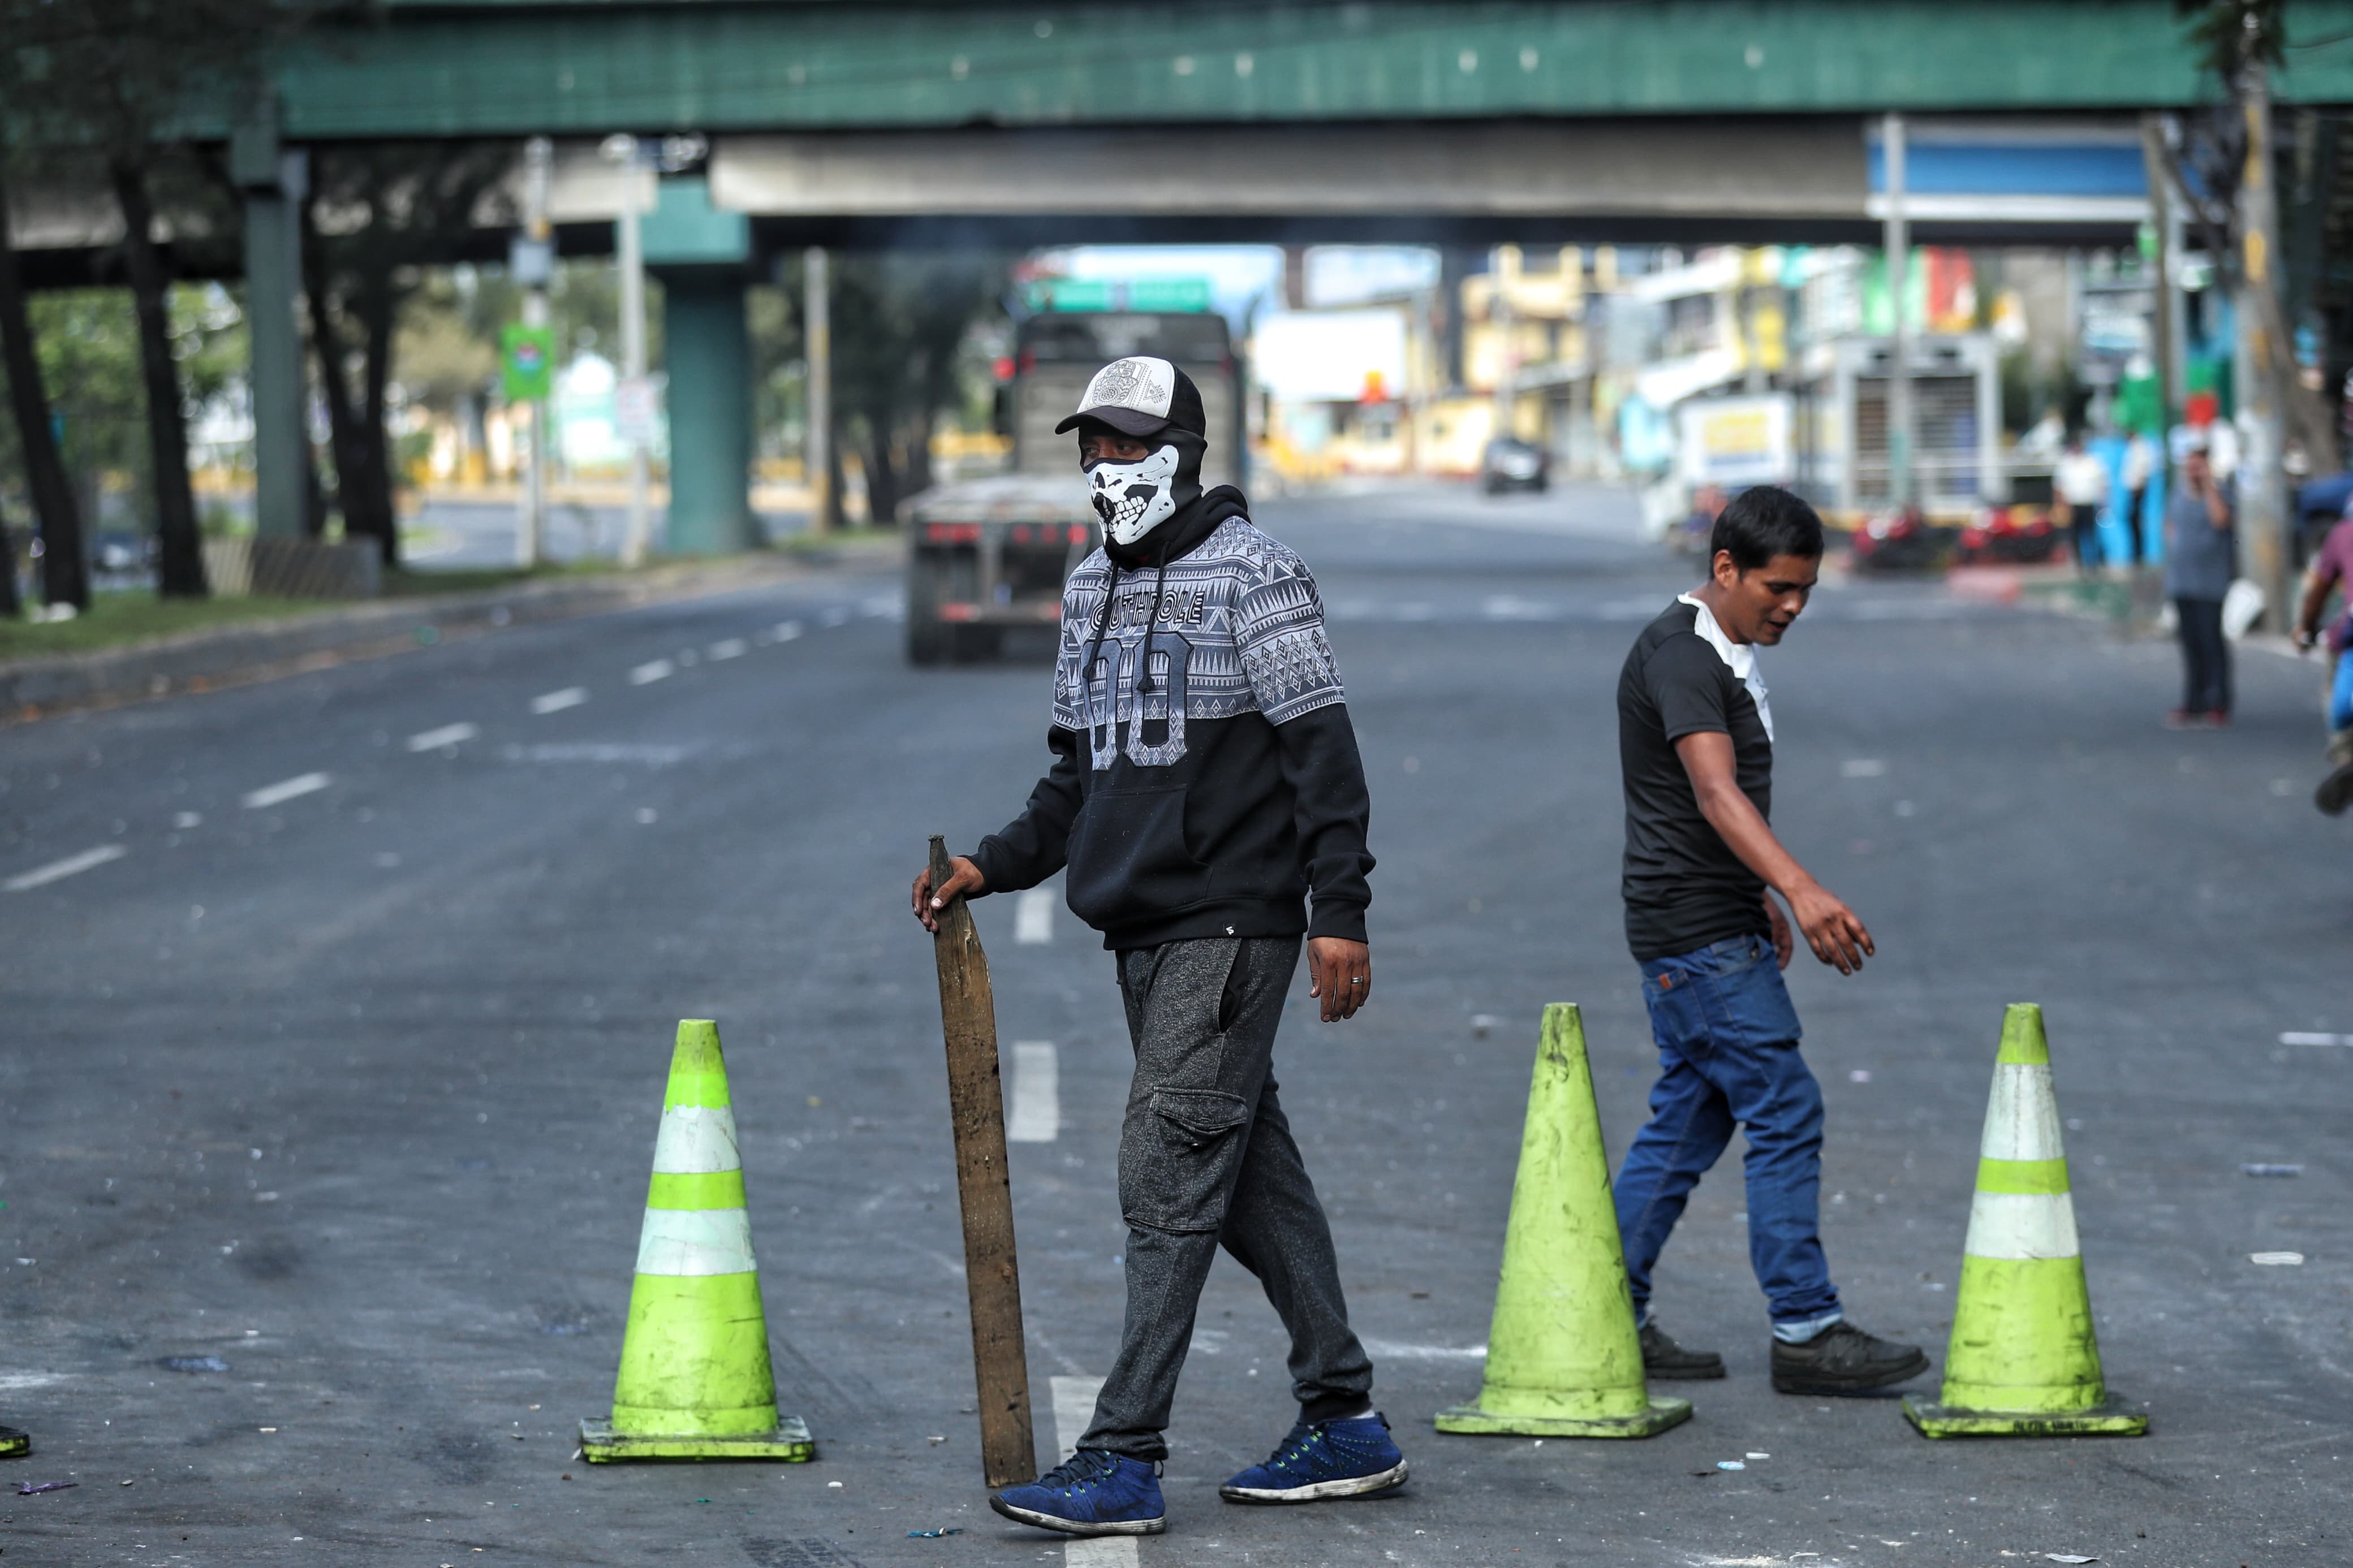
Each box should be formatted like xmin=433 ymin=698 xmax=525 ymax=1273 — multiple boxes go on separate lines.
xmin=1438 ymin=1001 xmax=1692 ymax=1436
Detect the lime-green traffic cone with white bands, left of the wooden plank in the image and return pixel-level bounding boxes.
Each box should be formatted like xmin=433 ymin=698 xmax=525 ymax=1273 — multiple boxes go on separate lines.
xmin=581 ymin=1018 xmax=817 ymax=1465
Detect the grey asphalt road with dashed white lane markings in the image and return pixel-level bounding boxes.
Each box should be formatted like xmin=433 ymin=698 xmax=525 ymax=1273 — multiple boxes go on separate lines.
xmin=0 ymin=491 xmax=2353 ymax=1568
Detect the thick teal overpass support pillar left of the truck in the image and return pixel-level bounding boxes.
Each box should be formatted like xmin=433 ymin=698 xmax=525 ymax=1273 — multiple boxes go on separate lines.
xmin=645 ymin=179 xmax=760 ymax=555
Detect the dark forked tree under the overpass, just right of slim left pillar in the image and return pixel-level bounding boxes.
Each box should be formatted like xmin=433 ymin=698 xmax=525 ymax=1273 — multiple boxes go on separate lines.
xmin=304 ymin=141 xmax=515 ymax=567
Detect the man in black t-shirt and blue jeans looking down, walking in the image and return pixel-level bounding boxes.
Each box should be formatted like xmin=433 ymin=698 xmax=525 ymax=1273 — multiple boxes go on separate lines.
xmin=1612 ymin=484 xmax=1927 ymax=1394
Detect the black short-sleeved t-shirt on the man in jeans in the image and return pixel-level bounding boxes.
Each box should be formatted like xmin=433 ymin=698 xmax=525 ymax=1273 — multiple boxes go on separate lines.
xmin=1619 ymin=599 xmax=1772 ymax=961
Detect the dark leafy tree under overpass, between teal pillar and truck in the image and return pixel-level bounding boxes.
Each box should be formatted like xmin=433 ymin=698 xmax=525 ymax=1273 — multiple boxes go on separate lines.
xmin=795 ymin=252 xmax=1010 ymax=524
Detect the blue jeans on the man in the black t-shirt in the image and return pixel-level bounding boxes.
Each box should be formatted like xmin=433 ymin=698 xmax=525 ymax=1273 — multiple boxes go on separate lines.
xmin=1614 ymin=936 xmax=1840 ymax=1326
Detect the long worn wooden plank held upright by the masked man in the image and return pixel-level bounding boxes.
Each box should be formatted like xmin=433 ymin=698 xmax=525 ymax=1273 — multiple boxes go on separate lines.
xmin=932 ymin=837 xmax=1038 ymax=1485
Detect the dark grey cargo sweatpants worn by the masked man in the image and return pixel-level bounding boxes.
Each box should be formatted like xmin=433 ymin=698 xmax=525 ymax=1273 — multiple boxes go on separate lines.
xmin=1080 ymin=936 xmax=1372 ymax=1460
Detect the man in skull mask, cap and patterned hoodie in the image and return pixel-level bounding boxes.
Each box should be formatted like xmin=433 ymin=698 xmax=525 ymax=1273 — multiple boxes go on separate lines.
xmin=915 ymin=357 xmax=1405 ymax=1535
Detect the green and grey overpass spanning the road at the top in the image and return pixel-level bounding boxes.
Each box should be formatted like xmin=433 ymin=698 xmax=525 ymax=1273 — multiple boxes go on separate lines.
xmin=23 ymin=0 xmax=2353 ymax=548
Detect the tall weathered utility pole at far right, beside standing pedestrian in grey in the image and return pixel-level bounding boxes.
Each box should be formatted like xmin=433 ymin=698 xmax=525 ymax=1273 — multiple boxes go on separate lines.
xmin=2233 ymin=61 xmax=2296 ymax=628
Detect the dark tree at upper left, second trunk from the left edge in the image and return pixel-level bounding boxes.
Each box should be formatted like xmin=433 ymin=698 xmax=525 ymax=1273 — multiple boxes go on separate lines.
xmin=0 ymin=0 xmax=339 ymax=597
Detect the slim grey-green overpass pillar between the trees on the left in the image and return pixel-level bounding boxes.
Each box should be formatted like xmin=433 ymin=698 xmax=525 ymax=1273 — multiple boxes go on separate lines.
xmin=229 ymin=106 xmax=311 ymax=538
